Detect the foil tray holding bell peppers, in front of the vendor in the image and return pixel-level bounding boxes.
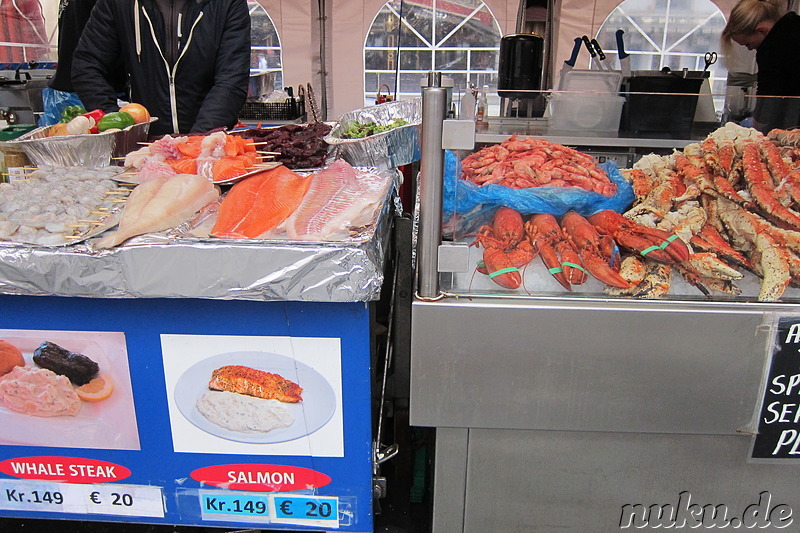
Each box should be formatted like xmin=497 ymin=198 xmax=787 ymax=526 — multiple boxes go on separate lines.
xmin=3 ymin=117 xmax=158 ymax=167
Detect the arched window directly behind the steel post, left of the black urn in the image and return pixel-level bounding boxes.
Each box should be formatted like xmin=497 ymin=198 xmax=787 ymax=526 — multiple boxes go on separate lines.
xmin=364 ymin=0 xmax=502 ymax=105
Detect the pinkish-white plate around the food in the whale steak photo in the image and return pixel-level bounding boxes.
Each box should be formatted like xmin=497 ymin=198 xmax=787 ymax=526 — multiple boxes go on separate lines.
xmin=0 ymin=330 xmax=139 ymax=450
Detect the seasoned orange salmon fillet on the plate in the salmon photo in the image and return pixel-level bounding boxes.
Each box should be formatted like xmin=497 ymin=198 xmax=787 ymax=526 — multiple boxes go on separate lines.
xmin=208 ymin=365 xmax=303 ymax=403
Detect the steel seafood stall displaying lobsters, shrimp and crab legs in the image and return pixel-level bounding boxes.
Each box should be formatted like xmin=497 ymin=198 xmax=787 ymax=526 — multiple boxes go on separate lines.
xmin=410 ymin=80 xmax=800 ymax=532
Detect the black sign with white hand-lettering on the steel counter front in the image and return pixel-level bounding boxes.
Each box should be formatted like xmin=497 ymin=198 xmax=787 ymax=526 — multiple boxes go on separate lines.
xmin=750 ymin=316 xmax=800 ymax=459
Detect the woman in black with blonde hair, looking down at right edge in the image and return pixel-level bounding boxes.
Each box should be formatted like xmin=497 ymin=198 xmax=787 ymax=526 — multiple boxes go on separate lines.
xmin=721 ymin=0 xmax=800 ymax=133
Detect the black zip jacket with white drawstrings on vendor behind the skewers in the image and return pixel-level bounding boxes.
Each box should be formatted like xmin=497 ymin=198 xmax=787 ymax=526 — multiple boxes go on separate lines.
xmin=72 ymin=0 xmax=250 ymax=135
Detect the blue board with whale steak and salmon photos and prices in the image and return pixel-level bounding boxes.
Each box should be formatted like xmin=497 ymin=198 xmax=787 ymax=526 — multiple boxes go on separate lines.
xmin=0 ymin=296 xmax=373 ymax=532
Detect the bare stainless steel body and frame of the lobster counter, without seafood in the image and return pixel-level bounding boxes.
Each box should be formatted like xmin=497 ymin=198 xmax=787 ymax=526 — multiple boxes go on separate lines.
xmin=410 ymin=81 xmax=800 ymax=533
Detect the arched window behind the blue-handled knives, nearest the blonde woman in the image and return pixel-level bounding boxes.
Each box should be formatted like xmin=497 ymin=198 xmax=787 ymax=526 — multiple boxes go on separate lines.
xmin=597 ymin=0 xmax=727 ymax=110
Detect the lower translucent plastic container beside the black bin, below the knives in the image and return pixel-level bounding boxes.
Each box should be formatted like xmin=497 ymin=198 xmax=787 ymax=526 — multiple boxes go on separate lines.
xmin=550 ymin=94 xmax=625 ymax=133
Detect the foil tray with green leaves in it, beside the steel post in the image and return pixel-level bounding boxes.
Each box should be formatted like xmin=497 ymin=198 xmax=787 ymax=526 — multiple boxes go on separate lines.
xmin=325 ymin=98 xmax=422 ymax=168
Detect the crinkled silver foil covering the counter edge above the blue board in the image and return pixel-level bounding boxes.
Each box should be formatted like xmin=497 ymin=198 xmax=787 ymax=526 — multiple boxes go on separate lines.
xmin=0 ymin=191 xmax=395 ymax=302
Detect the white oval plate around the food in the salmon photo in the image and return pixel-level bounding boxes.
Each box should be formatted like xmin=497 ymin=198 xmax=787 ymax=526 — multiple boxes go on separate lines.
xmin=174 ymin=351 xmax=336 ymax=444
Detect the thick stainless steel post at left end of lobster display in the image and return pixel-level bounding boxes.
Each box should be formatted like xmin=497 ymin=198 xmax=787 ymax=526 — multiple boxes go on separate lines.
xmin=417 ymin=72 xmax=447 ymax=298
